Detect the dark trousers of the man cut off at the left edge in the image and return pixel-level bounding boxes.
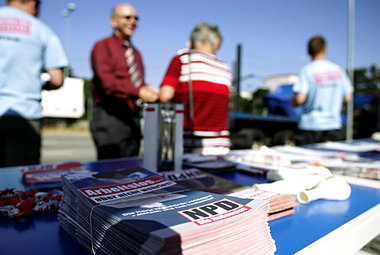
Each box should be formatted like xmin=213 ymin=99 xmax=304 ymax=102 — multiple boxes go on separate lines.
xmin=0 ymin=116 xmax=41 ymax=167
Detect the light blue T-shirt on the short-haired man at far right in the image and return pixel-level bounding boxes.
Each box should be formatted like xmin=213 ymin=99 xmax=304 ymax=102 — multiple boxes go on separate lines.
xmin=293 ymin=60 xmax=353 ymax=131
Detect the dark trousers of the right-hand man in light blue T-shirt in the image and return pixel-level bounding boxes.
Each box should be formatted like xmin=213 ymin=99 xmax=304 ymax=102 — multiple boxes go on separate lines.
xmin=296 ymin=129 xmax=344 ymax=145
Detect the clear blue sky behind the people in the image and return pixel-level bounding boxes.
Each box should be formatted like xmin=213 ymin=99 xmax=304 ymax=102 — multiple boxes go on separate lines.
xmin=0 ymin=0 xmax=380 ymax=91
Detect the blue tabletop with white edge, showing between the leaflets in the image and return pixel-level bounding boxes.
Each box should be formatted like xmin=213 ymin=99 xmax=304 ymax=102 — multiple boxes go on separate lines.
xmin=0 ymin=158 xmax=380 ymax=255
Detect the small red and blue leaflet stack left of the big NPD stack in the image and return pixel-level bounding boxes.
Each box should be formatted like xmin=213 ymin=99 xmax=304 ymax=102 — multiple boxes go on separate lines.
xmin=21 ymin=161 xmax=90 ymax=189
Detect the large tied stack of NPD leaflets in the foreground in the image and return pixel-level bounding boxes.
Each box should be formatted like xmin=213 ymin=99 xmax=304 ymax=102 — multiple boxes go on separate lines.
xmin=59 ymin=168 xmax=276 ymax=255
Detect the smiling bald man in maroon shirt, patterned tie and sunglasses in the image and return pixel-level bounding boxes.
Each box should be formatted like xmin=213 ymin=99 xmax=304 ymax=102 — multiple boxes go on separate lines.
xmin=91 ymin=3 xmax=158 ymax=159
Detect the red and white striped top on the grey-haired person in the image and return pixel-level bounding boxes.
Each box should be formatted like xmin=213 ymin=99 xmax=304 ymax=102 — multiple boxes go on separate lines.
xmin=161 ymin=50 xmax=231 ymax=154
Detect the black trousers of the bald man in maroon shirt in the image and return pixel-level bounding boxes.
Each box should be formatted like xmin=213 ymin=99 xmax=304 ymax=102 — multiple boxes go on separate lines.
xmin=90 ymin=105 xmax=141 ymax=159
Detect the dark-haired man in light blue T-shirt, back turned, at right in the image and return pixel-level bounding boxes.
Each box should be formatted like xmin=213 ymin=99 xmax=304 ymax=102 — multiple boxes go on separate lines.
xmin=292 ymin=36 xmax=353 ymax=144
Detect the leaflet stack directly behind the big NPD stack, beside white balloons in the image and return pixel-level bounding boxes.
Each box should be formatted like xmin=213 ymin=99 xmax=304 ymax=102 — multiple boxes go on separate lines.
xmin=160 ymin=168 xmax=298 ymax=221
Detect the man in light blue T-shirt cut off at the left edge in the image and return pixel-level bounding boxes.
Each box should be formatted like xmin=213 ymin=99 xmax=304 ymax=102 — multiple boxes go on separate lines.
xmin=0 ymin=0 xmax=68 ymax=167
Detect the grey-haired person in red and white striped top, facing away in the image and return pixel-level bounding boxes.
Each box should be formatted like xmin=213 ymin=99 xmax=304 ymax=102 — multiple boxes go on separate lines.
xmin=160 ymin=23 xmax=231 ymax=155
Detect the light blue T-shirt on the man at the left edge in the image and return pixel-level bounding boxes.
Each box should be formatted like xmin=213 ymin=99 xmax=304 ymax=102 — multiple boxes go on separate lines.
xmin=0 ymin=6 xmax=68 ymax=119
